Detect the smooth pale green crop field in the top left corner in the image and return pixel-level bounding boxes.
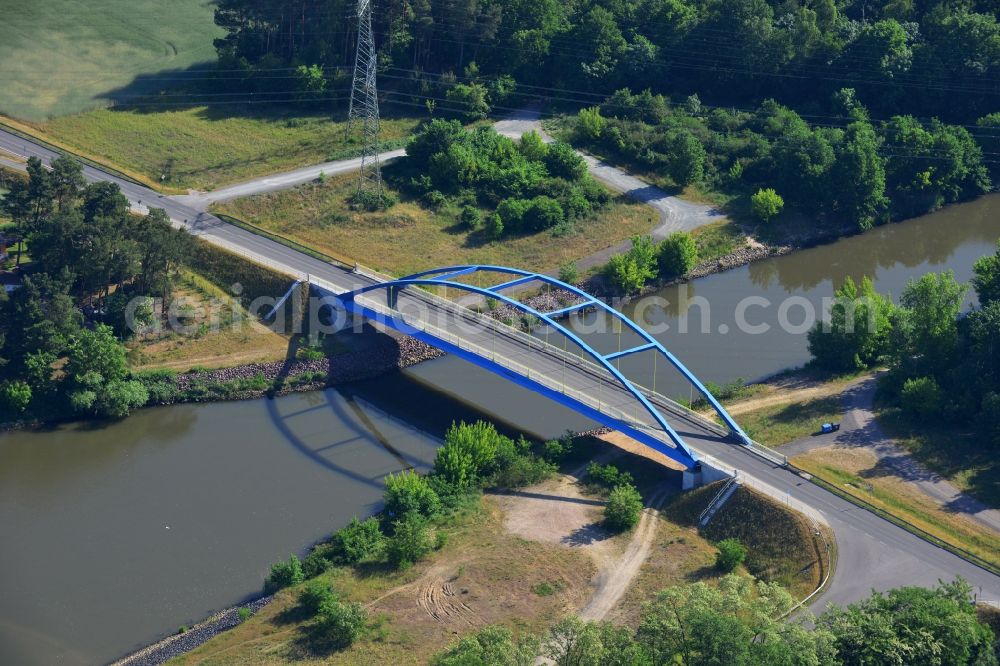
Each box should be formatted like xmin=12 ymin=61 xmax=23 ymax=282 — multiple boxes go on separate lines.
xmin=0 ymin=0 xmax=221 ymax=121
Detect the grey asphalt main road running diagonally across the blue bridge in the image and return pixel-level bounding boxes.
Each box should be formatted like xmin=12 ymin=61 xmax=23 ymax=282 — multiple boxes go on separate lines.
xmin=0 ymin=131 xmax=1000 ymax=609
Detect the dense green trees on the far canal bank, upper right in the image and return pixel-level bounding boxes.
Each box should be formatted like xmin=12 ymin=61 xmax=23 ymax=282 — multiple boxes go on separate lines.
xmin=573 ymin=89 xmax=991 ymax=229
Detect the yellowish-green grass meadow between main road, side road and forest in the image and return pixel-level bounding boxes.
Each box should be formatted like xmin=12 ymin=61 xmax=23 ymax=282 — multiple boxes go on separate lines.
xmin=34 ymin=106 xmax=418 ymax=190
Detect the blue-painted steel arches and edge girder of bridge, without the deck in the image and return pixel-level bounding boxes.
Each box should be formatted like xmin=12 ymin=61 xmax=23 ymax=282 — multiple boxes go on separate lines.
xmin=336 ymin=265 xmax=751 ymax=469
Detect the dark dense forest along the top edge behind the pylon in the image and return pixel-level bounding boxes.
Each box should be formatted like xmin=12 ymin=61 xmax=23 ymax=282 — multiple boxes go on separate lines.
xmin=216 ymin=0 xmax=1000 ymax=123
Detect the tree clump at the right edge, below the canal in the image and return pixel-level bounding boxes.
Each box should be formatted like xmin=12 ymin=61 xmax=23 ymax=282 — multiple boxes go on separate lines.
xmin=809 ymin=240 xmax=1000 ymax=449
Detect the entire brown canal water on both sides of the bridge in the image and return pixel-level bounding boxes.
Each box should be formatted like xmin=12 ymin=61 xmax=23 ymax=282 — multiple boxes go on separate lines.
xmin=0 ymin=196 xmax=1000 ymax=665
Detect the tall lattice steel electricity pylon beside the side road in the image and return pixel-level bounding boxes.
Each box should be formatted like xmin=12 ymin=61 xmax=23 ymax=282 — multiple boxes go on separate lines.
xmin=347 ymin=0 xmax=382 ymax=198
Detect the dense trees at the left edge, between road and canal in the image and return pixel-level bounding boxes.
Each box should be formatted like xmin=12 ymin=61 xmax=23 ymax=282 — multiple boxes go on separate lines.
xmin=0 ymin=158 xmax=192 ymax=417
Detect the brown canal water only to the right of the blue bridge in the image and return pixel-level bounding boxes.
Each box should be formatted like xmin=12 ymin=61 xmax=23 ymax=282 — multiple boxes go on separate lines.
xmin=560 ymin=195 xmax=1000 ymax=398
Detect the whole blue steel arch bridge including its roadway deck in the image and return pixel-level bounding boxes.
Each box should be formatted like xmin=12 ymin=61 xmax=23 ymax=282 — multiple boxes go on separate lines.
xmin=328 ymin=265 xmax=752 ymax=470
